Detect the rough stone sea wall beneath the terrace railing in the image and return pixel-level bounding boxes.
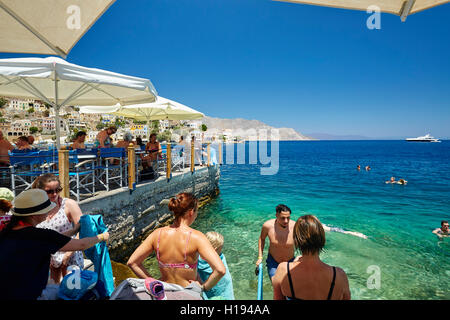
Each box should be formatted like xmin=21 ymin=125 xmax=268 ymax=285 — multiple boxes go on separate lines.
xmin=80 ymin=166 xmax=220 ymax=262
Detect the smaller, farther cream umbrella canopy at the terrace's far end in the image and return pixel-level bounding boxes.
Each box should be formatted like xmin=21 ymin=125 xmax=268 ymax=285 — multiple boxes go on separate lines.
xmin=113 ymin=97 xmax=205 ymax=121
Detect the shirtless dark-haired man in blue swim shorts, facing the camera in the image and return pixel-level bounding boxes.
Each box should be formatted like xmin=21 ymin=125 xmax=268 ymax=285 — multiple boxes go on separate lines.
xmin=256 ymin=204 xmax=295 ymax=280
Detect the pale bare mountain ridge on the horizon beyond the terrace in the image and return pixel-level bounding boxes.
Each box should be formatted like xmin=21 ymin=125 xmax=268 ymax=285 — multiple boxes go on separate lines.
xmin=202 ymin=116 xmax=316 ymax=141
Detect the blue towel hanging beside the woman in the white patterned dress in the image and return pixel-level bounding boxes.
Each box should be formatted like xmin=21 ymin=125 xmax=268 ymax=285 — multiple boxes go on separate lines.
xmin=80 ymin=214 xmax=114 ymax=296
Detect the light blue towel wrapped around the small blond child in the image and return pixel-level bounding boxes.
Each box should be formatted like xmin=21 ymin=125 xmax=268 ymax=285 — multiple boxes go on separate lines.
xmin=197 ymin=253 xmax=234 ymax=300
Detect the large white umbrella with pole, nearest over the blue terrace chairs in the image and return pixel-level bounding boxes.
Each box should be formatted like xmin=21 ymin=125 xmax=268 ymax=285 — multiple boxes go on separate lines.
xmin=0 ymin=57 xmax=157 ymax=149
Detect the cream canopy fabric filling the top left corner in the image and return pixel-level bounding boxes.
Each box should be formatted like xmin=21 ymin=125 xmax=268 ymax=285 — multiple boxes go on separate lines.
xmin=0 ymin=0 xmax=115 ymax=58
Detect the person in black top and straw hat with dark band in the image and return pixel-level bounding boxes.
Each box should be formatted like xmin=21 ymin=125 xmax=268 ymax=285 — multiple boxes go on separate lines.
xmin=0 ymin=189 xmax=109 ymax=300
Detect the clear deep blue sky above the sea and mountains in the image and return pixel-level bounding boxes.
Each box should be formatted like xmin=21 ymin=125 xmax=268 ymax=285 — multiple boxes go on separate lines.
xmin=0 ymin=0 xmax=450 ymax=138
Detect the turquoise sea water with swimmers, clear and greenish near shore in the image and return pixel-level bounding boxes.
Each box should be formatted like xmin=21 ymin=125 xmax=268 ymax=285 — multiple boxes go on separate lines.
xmin=192 ymin=141 xmax=450 ymax=300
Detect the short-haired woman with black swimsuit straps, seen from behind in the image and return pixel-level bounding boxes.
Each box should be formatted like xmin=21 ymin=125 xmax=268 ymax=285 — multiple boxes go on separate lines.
xmin=272 ymin=215 xmax=350 ymax=300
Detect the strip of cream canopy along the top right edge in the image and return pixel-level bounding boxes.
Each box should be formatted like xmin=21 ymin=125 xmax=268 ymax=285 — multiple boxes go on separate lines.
xmin=276 ymin=0 xmax=450 ymax=21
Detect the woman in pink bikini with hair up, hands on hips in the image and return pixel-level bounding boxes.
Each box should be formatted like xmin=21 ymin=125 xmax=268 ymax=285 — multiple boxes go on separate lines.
xmin=127 ymin=193 xmax=226 ymax=290
